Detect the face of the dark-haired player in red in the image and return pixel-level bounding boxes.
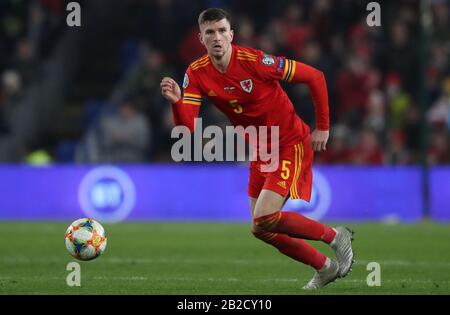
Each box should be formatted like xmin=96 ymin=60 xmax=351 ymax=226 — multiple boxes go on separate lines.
xmin=199 ymin=19 xmax=233 ymax=59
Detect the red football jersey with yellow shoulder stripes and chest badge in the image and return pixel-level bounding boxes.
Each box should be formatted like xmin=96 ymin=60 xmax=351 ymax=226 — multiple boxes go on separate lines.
xmin=183 ymin=45 xmax=309 ymax=153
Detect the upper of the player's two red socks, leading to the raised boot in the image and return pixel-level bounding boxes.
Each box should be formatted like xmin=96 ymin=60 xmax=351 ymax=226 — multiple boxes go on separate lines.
xmin=254 ymin=211 xmax=336 ymax=244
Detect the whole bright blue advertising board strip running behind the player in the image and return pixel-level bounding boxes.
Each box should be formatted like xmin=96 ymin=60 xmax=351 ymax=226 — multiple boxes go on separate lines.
xmin=0 ymin=164 xmax=426 ymax=222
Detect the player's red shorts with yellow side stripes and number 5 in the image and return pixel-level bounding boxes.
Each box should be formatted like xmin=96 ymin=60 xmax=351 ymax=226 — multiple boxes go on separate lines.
xmin=247 ymin=136 xmax=314 ymax=201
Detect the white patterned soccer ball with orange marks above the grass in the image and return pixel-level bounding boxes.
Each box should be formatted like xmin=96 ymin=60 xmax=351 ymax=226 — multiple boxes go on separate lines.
xmin=64 ymin=218 xmax=106 ymax=260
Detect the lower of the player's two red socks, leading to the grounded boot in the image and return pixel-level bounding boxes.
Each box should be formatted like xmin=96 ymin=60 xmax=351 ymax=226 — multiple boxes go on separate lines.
xmin=253 ymin=231 xmax=327 ymax=270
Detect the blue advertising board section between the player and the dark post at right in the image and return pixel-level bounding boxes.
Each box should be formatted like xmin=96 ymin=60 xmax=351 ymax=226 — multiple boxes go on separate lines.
xmin=285 ymin=166 xmax=423 ymax=223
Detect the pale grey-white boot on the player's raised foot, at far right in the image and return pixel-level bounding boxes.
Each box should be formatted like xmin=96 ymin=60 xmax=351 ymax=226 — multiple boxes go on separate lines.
xmin=330 ymin=226 xmax=355 ymax=278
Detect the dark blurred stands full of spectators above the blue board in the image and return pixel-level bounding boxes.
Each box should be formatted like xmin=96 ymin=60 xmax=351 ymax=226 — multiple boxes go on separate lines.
xmin=0 ymin=0 xmax=450 ymax=165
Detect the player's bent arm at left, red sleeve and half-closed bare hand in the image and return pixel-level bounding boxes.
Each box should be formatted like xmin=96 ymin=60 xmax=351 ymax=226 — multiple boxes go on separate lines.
xmin=160 ymin=69 xmax=201 ymax=132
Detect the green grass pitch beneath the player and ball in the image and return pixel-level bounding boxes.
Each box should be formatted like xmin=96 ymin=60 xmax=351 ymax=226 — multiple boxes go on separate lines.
xmin=0 ymin=222 xmax=450 ymax=294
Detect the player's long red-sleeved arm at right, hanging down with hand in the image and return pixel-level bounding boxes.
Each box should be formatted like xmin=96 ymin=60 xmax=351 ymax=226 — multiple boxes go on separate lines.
xmin=256 ymin=51 xmax=330 ymax=151
